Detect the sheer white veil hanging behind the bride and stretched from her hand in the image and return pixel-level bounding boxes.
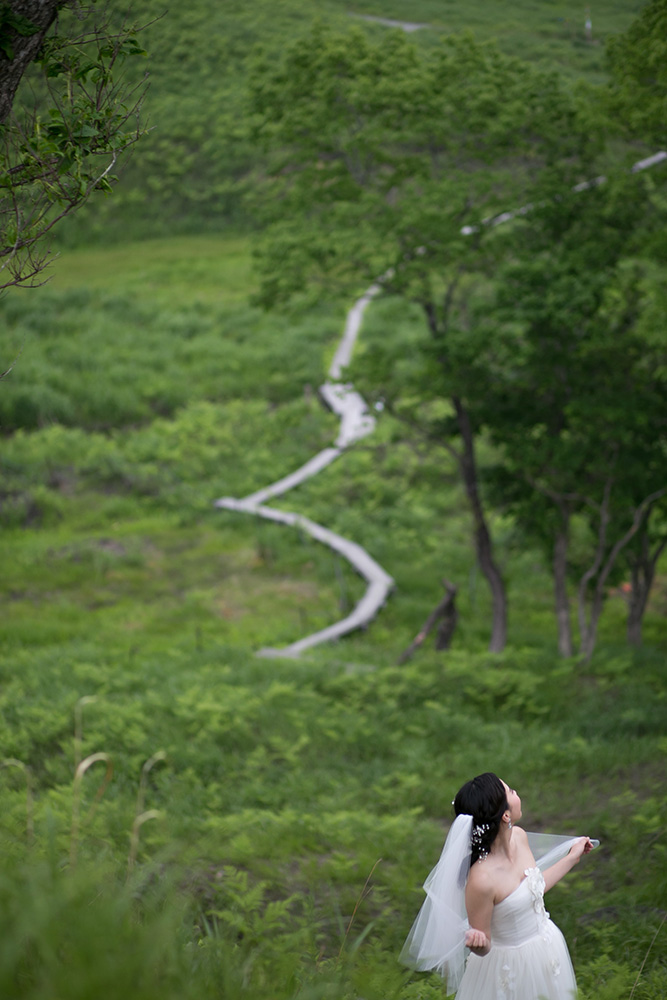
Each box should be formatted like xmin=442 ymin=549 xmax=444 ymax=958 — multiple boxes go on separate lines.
xmin=400 ymin=815 xmax=577 ymax=993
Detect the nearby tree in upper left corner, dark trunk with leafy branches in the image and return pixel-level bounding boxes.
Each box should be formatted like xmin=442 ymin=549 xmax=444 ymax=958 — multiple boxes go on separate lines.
xmin=0 ymin=0 xmax=149 ymax=290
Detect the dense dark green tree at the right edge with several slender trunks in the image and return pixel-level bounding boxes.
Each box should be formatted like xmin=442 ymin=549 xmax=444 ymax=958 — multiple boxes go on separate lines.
xmin=471 ymin=175 xmax=667 ymax=659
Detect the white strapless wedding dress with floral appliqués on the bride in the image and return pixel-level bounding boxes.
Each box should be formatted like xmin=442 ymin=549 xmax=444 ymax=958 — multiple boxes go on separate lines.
xmin=456 ymin=868 xmax=577 ymax=1000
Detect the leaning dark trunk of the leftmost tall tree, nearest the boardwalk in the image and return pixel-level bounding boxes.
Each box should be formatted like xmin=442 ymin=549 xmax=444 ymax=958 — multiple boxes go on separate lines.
xmin=452 ymin=396 xmax=507 ymax=653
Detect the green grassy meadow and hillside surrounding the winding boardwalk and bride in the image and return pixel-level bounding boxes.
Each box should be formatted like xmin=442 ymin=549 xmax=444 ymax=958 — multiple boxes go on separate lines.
xmin=0 ymin=0 xmax=667 ymax=1000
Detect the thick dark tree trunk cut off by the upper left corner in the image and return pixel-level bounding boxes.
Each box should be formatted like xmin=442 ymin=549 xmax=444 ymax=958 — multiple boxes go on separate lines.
xmin=0 ymin=0 xmax=65 ymax=123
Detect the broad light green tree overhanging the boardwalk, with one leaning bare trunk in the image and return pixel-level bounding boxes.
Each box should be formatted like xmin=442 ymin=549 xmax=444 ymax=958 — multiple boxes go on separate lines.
xmin=251 ymin=27 xmax=595 ymax=651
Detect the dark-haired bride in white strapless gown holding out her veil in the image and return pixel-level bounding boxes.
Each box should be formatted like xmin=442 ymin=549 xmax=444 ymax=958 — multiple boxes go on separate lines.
xmin=401 ymin=772 xmax=597 ymax=1000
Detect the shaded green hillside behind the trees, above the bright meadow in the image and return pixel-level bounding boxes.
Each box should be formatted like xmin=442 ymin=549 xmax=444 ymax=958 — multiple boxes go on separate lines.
xmin=52 ymin=0 xmax=640 ymax=243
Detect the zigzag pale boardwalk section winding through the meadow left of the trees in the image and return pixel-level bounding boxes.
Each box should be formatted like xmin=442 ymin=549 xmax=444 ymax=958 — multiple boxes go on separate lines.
xmin=215 ymin=285 xmax=394 ymax=657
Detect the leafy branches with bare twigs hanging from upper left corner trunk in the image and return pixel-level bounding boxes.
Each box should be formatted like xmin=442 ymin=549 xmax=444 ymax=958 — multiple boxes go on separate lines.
xmin=0 ymin=1 xmax=153 ymax=291
